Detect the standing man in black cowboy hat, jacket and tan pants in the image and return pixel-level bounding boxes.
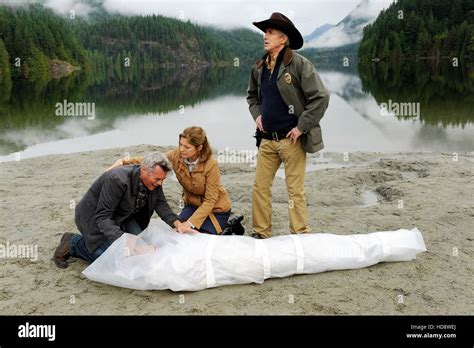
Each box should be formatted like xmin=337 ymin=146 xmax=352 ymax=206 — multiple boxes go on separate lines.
xmin=247 ymin=12 xmax=329 ymax=239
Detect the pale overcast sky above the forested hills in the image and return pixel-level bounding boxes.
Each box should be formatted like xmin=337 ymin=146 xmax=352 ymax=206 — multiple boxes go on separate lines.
xmin=0 ymin=0 xmax=380 ymax=35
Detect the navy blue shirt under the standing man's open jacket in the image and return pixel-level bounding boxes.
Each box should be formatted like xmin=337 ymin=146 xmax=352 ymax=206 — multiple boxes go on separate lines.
xmin=260 ymin=48 xmax=298 ymax=132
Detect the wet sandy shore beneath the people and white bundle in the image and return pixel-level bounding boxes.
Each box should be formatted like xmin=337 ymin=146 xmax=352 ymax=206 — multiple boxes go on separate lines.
xmin=0 ymin=145 xmax=474 ymax=315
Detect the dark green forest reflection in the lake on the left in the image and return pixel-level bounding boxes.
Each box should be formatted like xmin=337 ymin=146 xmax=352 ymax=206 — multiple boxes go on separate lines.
xmin=0 ymin=69 xmax=247 ymax=154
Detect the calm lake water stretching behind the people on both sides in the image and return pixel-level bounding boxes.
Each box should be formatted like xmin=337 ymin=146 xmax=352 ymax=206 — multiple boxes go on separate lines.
xmin=0 ymin=61 xmax=474 ymax=162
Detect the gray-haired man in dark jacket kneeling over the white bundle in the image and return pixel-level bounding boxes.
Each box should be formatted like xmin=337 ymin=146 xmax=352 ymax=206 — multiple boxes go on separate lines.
xmin=53 ymin=152 xmax=188 ymax=268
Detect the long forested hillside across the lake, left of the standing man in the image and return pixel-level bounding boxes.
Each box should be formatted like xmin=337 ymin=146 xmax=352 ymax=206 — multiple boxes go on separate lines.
xmin=0 ymin=4 xmax=262 ymax=90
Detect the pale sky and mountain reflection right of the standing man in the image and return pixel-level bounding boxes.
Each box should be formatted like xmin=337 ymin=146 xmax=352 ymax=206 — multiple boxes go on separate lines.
xmin=321 ymin=71 xmax=474 ymax=152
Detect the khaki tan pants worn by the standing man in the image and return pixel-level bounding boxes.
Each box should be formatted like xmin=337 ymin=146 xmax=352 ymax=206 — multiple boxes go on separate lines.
xmin=252 ymin=138 xmax=310 ymax=237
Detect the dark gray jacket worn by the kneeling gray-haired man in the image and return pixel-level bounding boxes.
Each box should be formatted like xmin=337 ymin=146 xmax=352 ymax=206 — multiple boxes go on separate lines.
xmin=75 ymin=165 xmax=178 ymax=253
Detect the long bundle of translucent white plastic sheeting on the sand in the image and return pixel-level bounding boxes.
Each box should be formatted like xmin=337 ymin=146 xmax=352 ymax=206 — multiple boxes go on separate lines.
xmin=83 ymin=220 xmax=426 ymax=291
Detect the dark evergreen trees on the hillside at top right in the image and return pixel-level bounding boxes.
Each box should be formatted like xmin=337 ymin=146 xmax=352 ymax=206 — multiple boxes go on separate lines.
xmin=358 ymin=0 xmax=474 ymax=61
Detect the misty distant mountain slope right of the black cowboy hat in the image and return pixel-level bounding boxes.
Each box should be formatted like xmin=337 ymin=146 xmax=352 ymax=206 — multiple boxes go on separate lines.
xmin=304 ymin=0 xmax=394 ymax=48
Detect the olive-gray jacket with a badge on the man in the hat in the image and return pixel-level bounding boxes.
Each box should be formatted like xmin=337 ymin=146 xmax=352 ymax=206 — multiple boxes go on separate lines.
xmin=247 ymin=48 xmax=329 ymax=153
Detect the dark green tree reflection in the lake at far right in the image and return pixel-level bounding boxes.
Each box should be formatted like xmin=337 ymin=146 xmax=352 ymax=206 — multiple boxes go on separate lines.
xmin=359 ymin=61 xmax=474 ymax=127
